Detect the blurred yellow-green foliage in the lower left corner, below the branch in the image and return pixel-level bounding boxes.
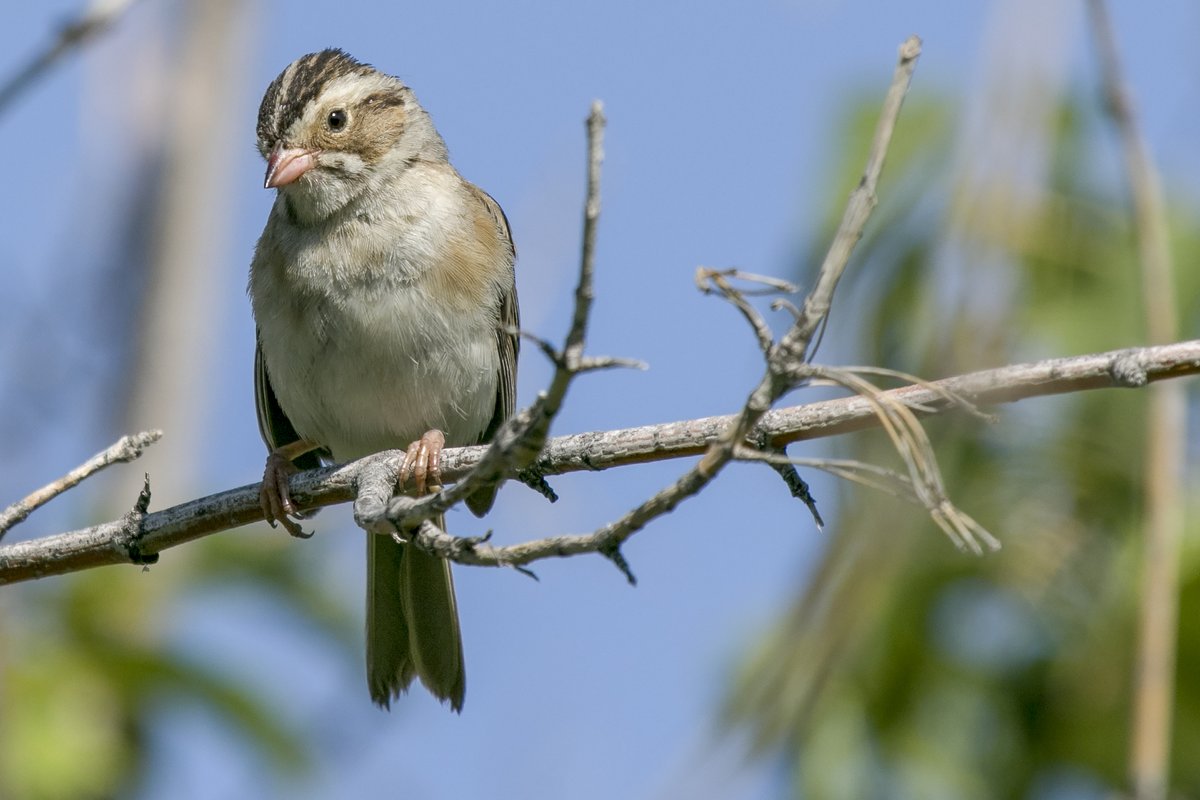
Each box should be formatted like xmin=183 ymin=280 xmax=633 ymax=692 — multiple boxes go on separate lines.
xmin=0 ymin=531 xmax=361 ymax=800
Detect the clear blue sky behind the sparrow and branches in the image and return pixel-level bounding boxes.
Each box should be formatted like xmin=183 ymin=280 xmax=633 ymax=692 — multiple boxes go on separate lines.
xmin=0 ymin=0 xmax=1200 ymax=799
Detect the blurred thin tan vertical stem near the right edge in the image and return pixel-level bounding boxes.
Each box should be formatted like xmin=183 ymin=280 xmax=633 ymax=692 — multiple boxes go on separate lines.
xmin=1088 ymin=0 xmax=1188 ymax=800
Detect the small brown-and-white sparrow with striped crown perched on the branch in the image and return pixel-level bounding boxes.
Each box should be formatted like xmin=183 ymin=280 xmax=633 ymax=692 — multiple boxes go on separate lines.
xmin=248 ymin=49 xmax=520 ymax=711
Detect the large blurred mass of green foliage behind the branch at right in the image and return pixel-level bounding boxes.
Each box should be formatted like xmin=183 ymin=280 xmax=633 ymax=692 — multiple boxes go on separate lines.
xmin=726 ymin=92 xmax=1200 ymax=799
